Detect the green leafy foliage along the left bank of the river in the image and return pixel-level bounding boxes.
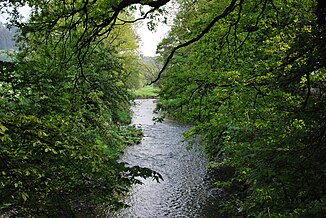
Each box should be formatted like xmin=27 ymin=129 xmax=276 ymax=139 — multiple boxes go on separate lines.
xmin=0 ymin=1 xmax=160 ymax=217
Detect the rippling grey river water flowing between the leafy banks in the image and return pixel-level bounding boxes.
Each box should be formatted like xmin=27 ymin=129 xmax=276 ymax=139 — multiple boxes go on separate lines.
xmin=110 ymin=99 xmax=219 ymax=218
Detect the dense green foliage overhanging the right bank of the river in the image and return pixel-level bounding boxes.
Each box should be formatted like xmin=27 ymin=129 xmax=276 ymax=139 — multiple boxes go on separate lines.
xmin=158 ymin=0 xmax=326 ymax=217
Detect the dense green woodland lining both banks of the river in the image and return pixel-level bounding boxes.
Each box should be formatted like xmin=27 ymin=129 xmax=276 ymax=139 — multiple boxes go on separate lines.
xmin=0 ymin=0 xmax=326 ymax=217
